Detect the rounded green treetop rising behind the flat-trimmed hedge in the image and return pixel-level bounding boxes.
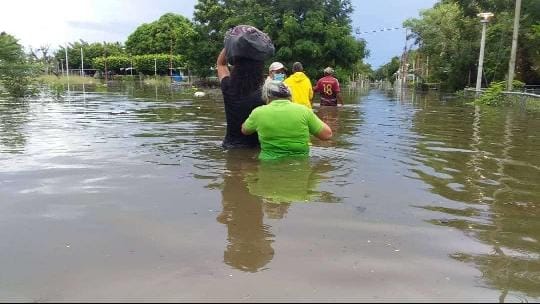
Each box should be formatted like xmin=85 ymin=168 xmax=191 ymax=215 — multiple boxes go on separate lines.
xmin=126 ymin=13 xmax=195 ymax=55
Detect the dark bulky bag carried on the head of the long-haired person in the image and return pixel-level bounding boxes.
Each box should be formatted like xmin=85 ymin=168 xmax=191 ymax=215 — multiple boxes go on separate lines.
xmin=224 ymin=25 xmax=275 ymax=64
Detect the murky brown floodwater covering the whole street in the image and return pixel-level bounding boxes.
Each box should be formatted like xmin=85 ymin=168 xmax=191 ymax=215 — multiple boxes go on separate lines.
xmin=0 ymin=83 xmax=540 ymax=302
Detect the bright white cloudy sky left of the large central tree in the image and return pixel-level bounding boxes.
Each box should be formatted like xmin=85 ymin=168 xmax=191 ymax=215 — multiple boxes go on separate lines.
xmin=0 ymin=0 xmax=196 ymax=48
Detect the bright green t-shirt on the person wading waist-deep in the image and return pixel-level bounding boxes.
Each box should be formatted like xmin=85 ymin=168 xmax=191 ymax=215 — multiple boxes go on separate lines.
xmin=244 ymin=100 xmax=324 ymax=160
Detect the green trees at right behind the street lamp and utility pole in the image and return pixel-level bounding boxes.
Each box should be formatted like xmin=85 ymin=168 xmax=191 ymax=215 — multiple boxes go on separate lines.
xmin=404 ymin=0 xmax=540 ymax=90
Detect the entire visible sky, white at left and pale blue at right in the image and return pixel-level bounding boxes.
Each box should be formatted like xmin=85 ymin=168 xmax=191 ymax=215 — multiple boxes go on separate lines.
xmin=0 ymin=0 xmax=437 ymax=68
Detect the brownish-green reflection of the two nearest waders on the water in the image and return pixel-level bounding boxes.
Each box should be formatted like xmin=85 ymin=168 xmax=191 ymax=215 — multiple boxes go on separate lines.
xmin=214 ymin=149 xmax=341 ymax=272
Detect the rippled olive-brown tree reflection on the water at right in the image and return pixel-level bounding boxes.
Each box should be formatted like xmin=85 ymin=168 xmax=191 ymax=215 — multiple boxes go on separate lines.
xmin=413 ymin=93 xmax=540 ymax=301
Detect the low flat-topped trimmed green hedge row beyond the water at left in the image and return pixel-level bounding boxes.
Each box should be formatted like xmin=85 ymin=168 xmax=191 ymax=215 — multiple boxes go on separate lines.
xmin=93 ymin=54 xmax=186 ymax=75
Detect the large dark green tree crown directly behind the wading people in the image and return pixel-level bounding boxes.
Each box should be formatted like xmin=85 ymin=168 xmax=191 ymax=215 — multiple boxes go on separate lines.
xmin=188 ymin=0 xmax=367 ymax=80
